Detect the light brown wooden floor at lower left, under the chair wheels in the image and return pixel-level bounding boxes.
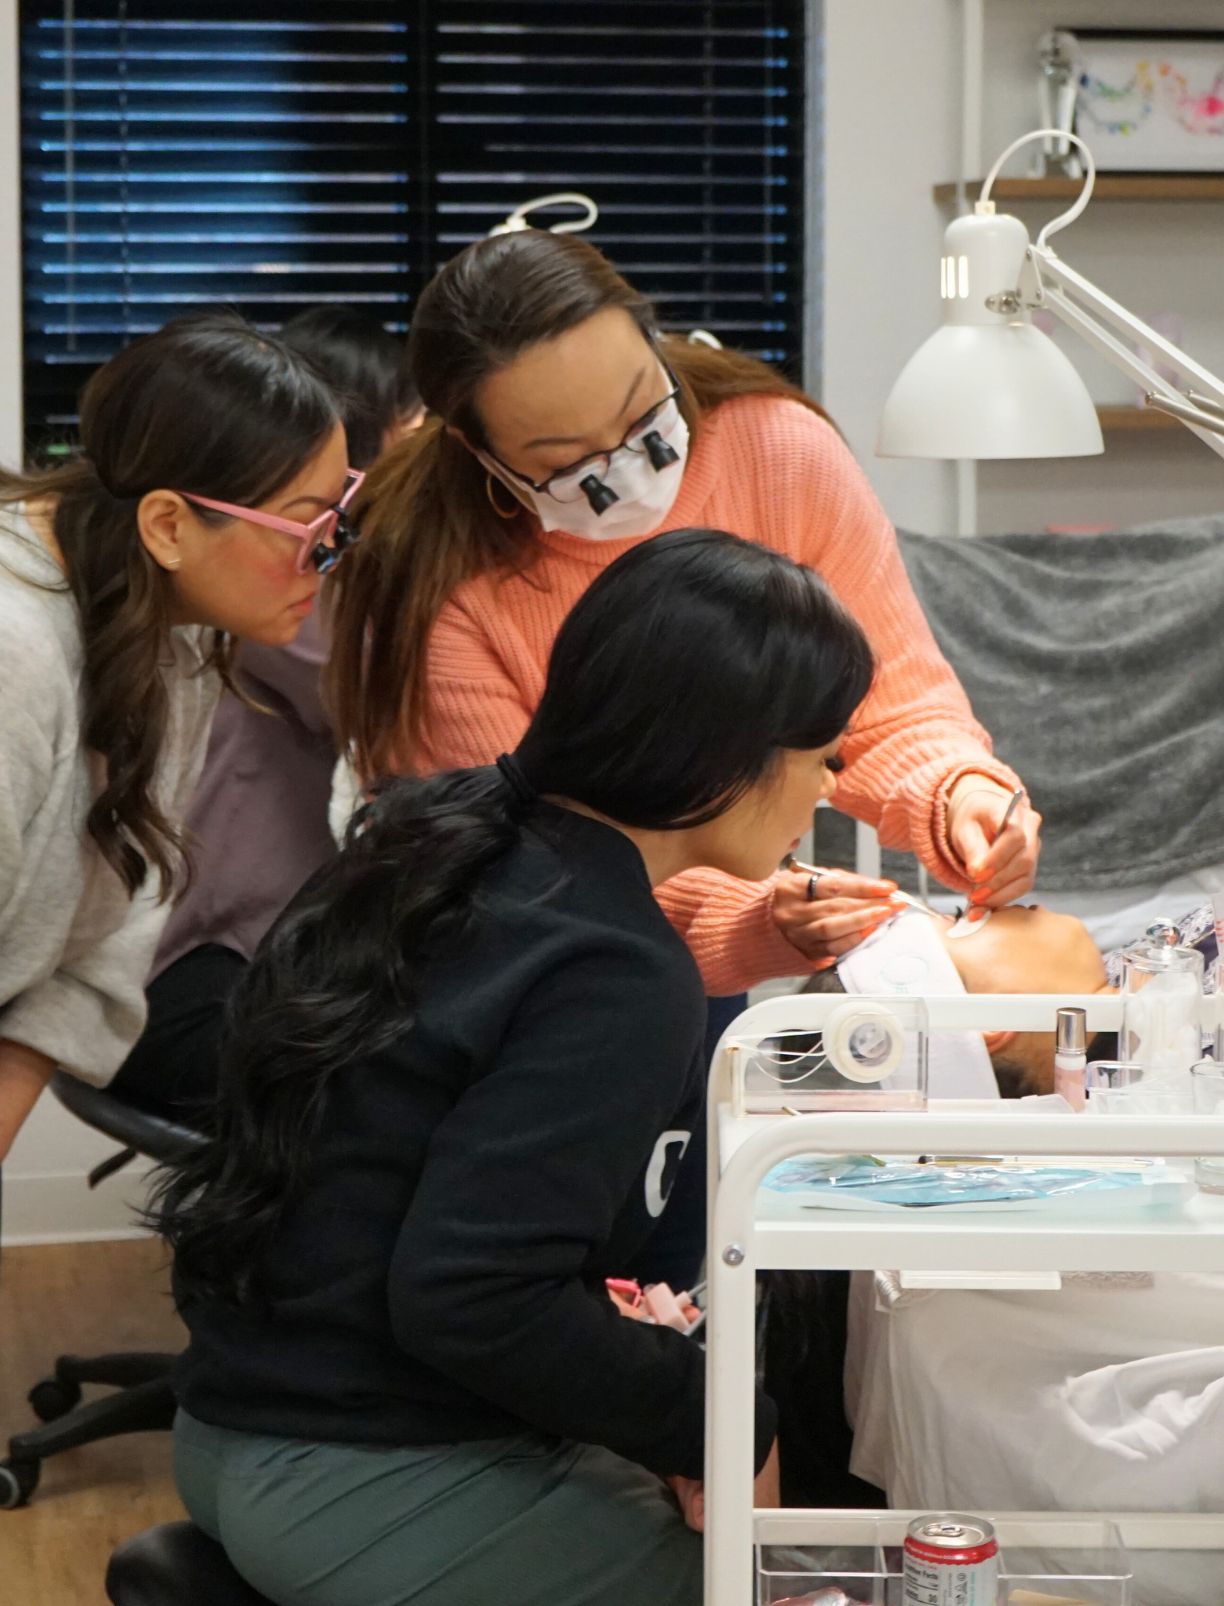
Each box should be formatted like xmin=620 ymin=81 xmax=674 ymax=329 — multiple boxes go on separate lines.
xmin=0 ymin=1240 xmax=183 ymax=1606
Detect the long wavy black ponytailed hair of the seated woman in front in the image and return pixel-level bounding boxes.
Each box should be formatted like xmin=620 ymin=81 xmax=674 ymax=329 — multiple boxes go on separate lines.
xmin=151 ymin=530 xmax=872 ymax=1302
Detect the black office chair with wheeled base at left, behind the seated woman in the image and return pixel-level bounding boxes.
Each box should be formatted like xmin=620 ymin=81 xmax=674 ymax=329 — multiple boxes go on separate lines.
xmin=0 ymin=1071 xmax=204 ymax=1511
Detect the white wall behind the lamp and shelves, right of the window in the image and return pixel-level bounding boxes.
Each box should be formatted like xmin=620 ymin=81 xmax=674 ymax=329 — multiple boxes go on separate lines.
xmin=824 ymin=0 xmax=1224 ymax=532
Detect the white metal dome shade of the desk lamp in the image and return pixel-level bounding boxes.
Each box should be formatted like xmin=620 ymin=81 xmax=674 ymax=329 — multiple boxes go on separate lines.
xmin=877 ymin=215 xmax=1105 ymax=458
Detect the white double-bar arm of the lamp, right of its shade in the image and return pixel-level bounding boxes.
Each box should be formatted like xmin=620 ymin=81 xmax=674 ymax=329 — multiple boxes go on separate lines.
xmin=1022 ymin=246 xmax=1224 ymax=456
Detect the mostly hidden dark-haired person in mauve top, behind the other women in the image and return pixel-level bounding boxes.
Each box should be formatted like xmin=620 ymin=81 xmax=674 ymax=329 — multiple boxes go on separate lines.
xmin=112 ymin=305 xmax=421 ymax=1126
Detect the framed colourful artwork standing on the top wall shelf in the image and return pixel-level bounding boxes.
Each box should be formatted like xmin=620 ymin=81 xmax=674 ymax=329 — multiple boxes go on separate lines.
xmin=1067 ymin=29 xmax=1224 ymax=173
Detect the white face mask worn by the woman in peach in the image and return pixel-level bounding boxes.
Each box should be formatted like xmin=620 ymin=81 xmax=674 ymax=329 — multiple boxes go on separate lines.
xmin=475 ymin=400 xmax=689 ymax=541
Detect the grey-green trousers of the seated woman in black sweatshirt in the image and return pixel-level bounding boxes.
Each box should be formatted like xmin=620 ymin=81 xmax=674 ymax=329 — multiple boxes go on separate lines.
xmin=175 ymin=1412 xmax=702 ymax=1606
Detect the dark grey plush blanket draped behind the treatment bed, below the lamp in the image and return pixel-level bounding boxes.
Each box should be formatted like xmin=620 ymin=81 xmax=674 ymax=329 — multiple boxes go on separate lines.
xmin=821 ymin=519 xmax=1224 ymax=890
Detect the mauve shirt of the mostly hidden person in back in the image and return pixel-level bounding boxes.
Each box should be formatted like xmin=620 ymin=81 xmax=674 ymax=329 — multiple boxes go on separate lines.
xmin=153 ymin=615 xmax=336 ymax=976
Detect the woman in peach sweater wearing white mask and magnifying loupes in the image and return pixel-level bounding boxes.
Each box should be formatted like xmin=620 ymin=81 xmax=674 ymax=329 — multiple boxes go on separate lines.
xmin=331 ymin=230 xmax=1041 ymax=1278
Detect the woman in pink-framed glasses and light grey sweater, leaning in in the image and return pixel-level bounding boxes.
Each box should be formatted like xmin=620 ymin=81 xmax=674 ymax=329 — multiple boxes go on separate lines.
xmin=0 ymin=313 xmax=360 ymax=1158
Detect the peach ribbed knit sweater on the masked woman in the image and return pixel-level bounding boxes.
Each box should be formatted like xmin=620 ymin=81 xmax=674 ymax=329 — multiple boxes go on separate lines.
xmin=414 ymin=397 xmax=1017 ymax=994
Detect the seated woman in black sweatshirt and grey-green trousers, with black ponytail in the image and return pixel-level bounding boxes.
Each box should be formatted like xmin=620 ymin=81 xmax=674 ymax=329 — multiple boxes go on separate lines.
xmin=157 ymin=530 xmax=872 ymax=1606
